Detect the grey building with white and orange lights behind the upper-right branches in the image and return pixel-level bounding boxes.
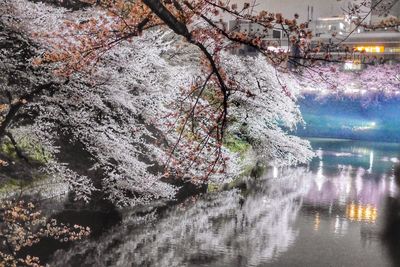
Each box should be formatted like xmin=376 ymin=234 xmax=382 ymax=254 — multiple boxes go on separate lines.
xmin=225 ymin=0 xmax=400 ymax=63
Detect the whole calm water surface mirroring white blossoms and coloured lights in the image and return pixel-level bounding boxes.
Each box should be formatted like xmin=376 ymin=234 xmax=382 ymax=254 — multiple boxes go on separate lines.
xmin=52 ymin=139 xmax=400 ymax=267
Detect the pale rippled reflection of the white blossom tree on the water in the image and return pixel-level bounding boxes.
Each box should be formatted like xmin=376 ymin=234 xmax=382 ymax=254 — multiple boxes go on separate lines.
xmin=50 ymin=169 xmax=308 ymax=266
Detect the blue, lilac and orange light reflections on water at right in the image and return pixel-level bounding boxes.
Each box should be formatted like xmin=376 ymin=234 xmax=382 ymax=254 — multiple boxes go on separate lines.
xmin=280 ymin=139 xmax=400 ymax=266
